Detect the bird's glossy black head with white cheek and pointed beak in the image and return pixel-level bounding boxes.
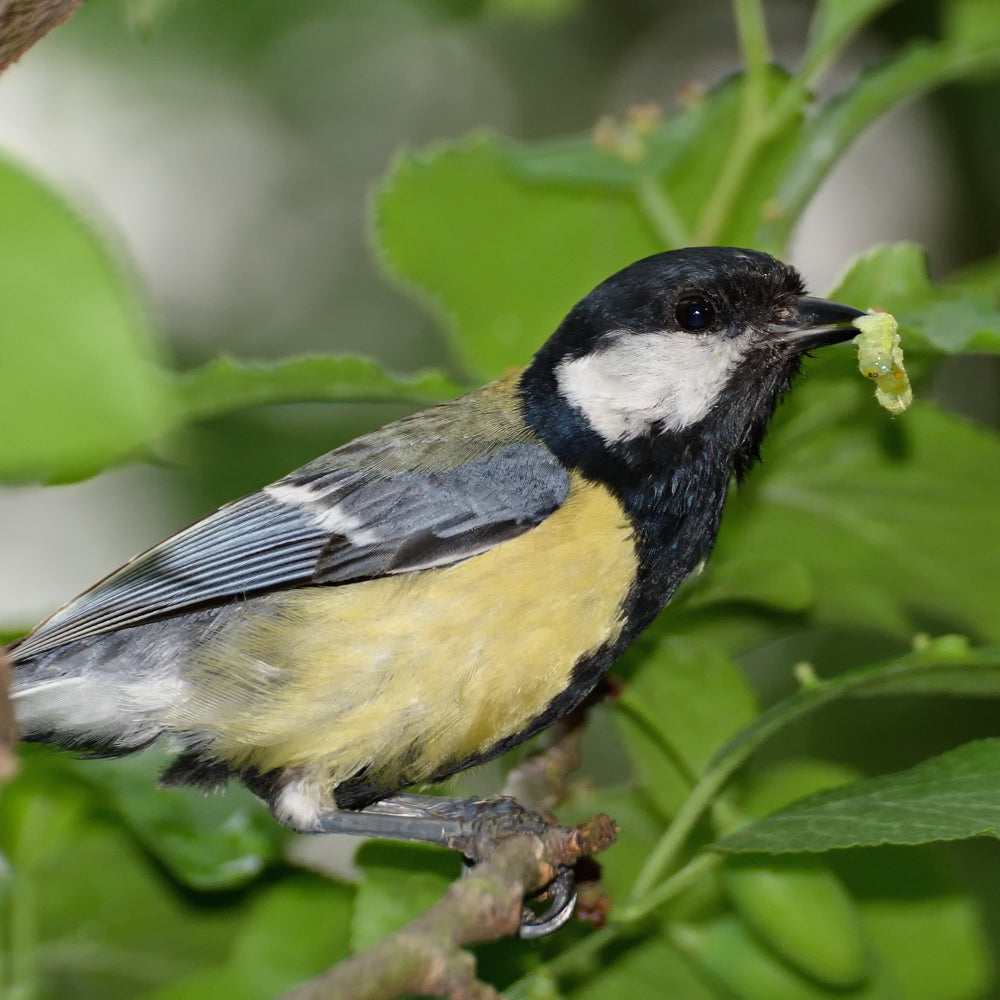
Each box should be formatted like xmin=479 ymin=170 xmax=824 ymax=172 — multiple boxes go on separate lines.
xmin=522 ymin=247 xmax=862 ymax=472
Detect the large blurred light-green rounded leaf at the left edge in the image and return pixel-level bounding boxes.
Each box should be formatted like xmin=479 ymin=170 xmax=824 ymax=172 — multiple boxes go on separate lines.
xmin=0 ymin=162 xmax=174 ymax=481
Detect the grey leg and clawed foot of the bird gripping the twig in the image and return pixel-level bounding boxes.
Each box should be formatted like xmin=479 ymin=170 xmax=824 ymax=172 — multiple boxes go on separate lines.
xmin=302 ymin=793 xmax=576 ymax=939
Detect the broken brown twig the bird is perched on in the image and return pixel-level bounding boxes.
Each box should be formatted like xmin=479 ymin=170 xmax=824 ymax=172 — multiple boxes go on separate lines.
xmin=284 ymin=815 xmax=615 ymax=1000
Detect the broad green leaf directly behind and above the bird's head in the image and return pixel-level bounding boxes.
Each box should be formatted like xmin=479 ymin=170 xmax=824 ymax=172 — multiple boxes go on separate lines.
xmin=375 ymin=135 xmax=662 ymax=375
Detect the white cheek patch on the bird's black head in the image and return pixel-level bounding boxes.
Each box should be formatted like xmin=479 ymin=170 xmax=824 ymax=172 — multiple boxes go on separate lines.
xmin=556 ymin=330 xmax=749 ymax=443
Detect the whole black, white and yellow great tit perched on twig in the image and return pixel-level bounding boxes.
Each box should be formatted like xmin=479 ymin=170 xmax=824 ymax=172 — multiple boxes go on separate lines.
xmin=3 ymin=247 xmax=862 ymax=929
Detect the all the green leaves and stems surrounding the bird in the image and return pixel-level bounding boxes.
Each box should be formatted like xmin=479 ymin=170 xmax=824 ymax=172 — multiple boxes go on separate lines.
xmin=0 ymin=0 xmax=1000 ymax=1000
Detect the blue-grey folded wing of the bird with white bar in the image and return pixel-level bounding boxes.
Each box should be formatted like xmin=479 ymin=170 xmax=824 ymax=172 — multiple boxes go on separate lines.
xmin=13 ymin=439 xmax=569 ymax=660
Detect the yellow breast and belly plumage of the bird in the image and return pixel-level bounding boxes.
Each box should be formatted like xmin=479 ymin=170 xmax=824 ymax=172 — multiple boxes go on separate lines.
xmin=170 ymin=477 xmax=636 ymax=787
